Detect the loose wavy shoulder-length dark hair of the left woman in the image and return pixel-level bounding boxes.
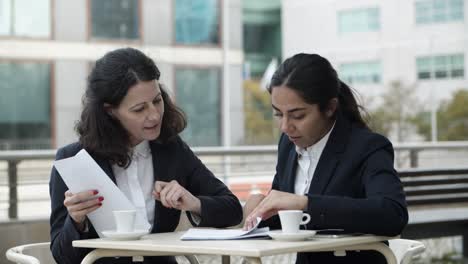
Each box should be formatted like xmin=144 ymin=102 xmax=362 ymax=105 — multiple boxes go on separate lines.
xmin=75 ymin=48 xmax=187 ymax=166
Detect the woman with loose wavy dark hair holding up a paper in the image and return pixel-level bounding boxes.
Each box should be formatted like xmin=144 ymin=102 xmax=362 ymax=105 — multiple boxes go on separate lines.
xmin=49 ymin=48 xmax=242 ymax=263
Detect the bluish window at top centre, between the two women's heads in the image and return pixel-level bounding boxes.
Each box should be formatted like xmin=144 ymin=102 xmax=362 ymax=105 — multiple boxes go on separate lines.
xmin=175 ymin=0 xmax=220 ymax=45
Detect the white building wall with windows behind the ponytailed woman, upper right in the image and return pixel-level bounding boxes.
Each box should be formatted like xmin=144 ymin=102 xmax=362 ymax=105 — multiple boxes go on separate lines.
xmin=282 ymin=0 xmax=468 ymax=107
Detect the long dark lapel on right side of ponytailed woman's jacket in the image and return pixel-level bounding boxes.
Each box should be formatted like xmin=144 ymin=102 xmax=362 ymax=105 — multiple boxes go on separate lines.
xmin=309 ymin=112 xmax=351 ymax=194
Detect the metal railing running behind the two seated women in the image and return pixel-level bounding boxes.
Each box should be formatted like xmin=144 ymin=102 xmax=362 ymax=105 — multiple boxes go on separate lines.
xmin=0 ymin=141 xmax=468 ymax=219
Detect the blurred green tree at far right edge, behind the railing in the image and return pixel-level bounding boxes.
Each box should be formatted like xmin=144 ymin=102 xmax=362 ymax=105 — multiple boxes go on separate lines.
xmin=414 ymin=89 xmax=468 ymax=140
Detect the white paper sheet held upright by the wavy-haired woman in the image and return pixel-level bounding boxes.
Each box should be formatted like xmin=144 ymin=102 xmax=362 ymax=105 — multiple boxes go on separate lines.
xmin=54 ymin=149 xmax=151 ymax=237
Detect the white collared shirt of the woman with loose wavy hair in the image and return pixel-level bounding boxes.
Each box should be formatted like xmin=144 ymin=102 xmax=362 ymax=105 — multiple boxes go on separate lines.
xmin=112 ymin=140 xmax=155 ymax=226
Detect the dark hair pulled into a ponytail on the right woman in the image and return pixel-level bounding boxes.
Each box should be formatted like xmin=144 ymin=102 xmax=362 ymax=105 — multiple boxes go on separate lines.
xmin=268 ymin=53 xmax=367 ymax=127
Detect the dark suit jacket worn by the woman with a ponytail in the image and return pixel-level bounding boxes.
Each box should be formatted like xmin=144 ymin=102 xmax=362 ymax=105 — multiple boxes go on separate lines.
xmin=267 ymin=113 xmax=408 ymax=263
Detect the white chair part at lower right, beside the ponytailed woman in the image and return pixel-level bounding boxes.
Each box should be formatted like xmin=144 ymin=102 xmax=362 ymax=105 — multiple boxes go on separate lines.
xmin=388 ymin=238 xmax=426 ymax=264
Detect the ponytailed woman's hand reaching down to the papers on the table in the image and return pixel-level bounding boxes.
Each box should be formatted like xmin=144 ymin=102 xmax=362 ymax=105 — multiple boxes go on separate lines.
xmin=244 ymin=190 xmax=309 ymax=229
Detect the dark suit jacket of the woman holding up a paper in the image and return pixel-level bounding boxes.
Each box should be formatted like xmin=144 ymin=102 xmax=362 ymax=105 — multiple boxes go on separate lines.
xmin=49 ymin=137 xmax=242 ymax=264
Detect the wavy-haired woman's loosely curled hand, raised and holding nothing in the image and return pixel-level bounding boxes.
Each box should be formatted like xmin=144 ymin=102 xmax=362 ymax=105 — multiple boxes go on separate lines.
xmin=153 ymin=180 xmax=201 ymax=214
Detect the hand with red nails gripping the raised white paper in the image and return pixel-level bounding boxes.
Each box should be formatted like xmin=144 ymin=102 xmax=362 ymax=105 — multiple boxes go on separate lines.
xmin=63 ymin=190 xmax=104 ymax=226
